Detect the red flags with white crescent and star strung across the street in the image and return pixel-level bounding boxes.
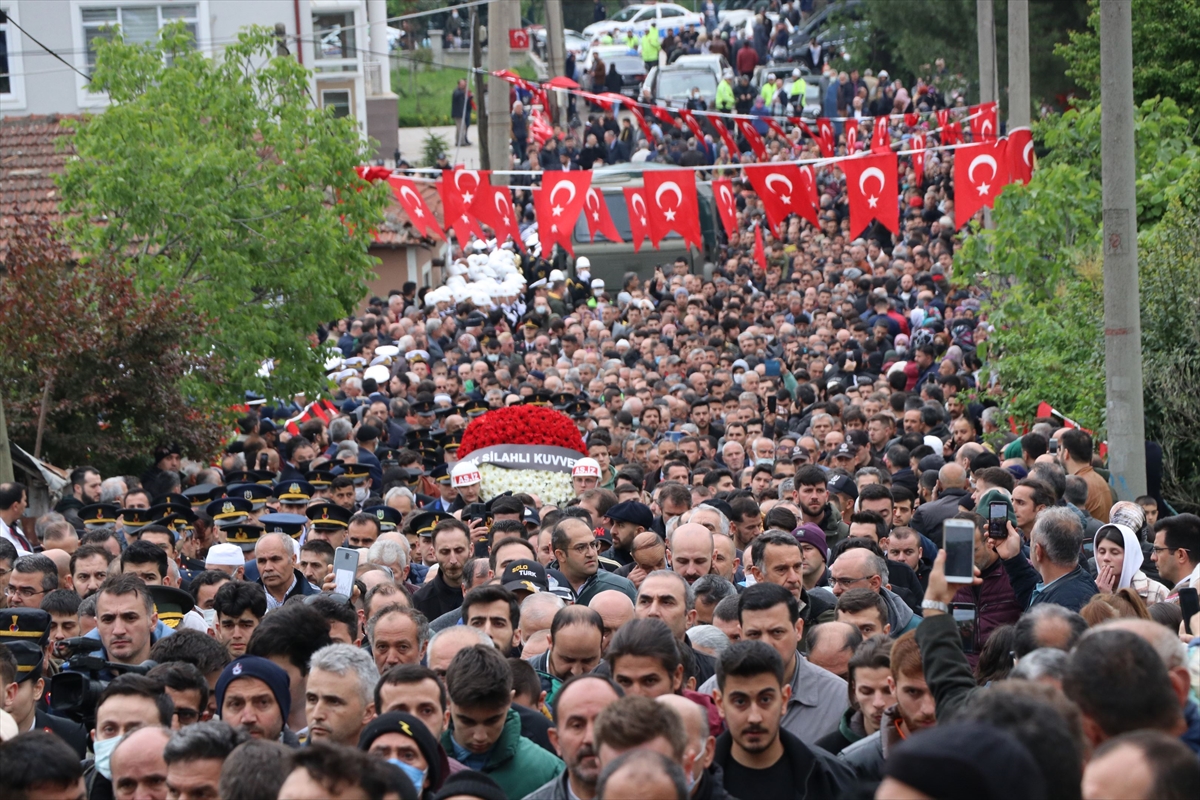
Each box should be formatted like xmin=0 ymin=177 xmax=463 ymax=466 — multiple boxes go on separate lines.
xmin=359 ymin=90 xmax=1033 ymax=248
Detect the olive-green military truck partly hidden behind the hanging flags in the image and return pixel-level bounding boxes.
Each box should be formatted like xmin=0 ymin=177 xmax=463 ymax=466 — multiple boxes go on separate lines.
xmin=571 ymin=162 xmax=720 ymax=287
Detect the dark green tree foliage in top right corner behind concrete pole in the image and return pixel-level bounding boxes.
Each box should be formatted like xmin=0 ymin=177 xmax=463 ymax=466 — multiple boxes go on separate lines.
xmin=1055 ymin=0 xmax=1200 ymax=113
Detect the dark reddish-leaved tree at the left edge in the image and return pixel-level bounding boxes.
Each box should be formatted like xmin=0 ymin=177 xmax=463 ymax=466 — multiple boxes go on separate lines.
xmin=0 ymin=217 xmax=226 ymax=474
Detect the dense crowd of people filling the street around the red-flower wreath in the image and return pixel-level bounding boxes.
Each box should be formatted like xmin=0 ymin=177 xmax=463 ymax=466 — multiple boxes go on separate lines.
xmin=0 ymin=4 xmax=1200 ymax=800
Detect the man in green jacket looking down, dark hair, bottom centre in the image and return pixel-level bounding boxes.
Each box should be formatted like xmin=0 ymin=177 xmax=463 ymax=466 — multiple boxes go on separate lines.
xmin=442 ymin=644 xmax=563 ymax=798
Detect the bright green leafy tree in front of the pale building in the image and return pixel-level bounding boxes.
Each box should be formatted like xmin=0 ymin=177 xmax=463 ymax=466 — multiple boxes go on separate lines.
xmin=60 ymin=24 xmax=388 ymax=402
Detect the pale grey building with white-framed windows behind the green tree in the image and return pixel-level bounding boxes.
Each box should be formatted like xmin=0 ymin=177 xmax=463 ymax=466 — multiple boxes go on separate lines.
xmin=0 ymin=0 xmax=397 ymax=160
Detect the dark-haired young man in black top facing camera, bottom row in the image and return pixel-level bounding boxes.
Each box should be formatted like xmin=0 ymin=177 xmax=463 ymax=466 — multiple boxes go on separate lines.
xmin=713 ymin=642 xmax=853 ymax=798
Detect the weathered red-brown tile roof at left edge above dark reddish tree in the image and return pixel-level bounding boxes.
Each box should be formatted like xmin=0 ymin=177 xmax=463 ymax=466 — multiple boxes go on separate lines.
xmin=0 ymin=114 xmax=80 ymax=260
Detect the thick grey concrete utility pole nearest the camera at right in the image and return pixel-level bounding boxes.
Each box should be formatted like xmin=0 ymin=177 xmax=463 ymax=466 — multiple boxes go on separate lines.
xmin=1100 ymin=0 xmax=1146 ymax=500
